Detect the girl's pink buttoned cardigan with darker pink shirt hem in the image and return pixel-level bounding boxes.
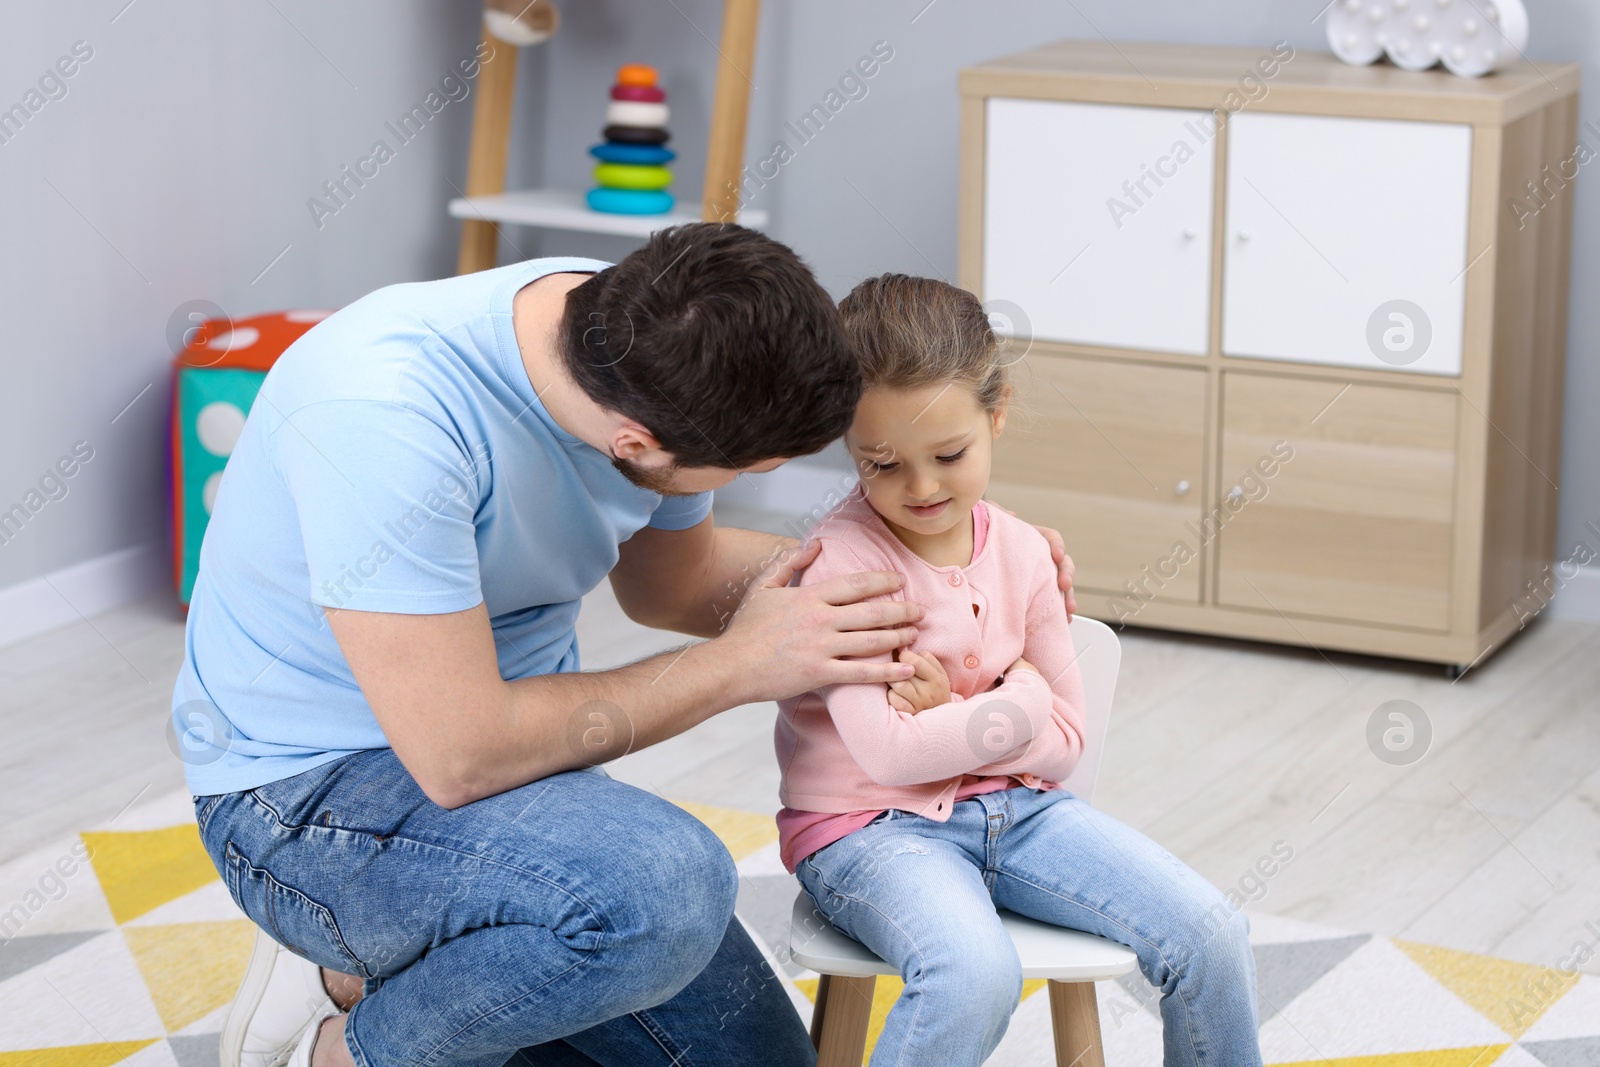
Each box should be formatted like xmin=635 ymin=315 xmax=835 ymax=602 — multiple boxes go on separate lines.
xmin=776 ymin=486 xmax=1083 ymax=872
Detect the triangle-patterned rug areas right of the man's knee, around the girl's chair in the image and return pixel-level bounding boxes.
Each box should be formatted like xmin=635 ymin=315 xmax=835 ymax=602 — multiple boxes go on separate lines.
xmin=713 ymin=805 xmax=1600 ymax=1067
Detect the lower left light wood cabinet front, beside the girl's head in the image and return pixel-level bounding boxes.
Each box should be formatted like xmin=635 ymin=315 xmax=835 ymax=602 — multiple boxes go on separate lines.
xmin=989 ymin=354 xmax=1206 ymax=611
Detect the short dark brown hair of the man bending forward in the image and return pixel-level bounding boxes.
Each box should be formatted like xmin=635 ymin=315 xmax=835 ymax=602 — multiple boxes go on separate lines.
xmin=562 ymin=222 xmax=861 ymax=469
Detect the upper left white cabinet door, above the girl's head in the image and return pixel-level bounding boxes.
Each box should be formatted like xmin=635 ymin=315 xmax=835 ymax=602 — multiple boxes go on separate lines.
xmin=982 ymin=98 xmax=1216 ymax=355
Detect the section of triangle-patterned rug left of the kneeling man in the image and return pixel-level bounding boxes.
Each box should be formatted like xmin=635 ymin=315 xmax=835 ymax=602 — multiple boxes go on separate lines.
xmin=0 ymin=792 xmax=256 ymax=1067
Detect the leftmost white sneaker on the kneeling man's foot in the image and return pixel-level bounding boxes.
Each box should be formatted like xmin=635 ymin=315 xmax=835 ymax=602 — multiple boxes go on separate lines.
xmin=218 ymin=929 xmax=339 ymax=1067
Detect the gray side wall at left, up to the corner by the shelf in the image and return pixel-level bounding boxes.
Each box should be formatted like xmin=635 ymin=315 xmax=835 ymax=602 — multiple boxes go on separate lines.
xmin=0 ymin=0 xmax=480 ymax=589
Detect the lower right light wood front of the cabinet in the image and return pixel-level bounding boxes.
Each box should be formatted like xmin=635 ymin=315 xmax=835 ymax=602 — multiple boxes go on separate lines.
xmin=1218 ymin=371 xmax=1458 ymax=630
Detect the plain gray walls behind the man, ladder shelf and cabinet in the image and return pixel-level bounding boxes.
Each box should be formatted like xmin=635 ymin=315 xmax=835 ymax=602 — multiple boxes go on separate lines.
xmin=0 ymin=0 xmax=1600 ymax=587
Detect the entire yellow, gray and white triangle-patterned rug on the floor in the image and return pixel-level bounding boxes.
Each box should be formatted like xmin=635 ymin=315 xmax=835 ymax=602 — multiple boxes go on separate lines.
xmin=0 ymin=792 xmax=1600 ymax=1067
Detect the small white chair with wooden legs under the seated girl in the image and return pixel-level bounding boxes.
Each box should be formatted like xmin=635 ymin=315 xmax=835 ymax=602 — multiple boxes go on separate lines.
xmin=789 ymin=616 xmax=1139 ymax=1067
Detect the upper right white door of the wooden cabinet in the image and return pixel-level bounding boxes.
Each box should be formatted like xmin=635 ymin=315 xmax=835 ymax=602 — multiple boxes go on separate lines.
xmin=1222 ymin=114 xmax=1472 ymax=374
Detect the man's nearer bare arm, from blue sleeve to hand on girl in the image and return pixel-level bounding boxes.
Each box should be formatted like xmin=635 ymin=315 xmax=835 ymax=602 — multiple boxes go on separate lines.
xmin=328 ymin=547 xmax=922 ymax=808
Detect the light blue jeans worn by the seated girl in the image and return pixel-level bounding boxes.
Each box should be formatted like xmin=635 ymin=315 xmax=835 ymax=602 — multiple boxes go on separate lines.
xmin=797 ymin=787 xmax=1261 ymax=1067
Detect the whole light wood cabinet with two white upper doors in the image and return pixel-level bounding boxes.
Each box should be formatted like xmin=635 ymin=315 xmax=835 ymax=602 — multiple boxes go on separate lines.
xmin=958 ymin=40 xmax=1579 ymax=667
